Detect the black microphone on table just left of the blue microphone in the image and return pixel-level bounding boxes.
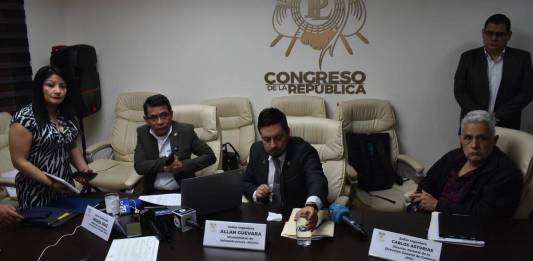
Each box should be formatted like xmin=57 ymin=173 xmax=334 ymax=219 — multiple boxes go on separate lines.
xmin=141 ymin=207 xmax=174 ymax=240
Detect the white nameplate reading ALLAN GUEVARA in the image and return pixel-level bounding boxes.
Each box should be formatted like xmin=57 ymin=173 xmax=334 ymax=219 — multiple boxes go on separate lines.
xmin=204 ymin=220 xmax=266 ymax=251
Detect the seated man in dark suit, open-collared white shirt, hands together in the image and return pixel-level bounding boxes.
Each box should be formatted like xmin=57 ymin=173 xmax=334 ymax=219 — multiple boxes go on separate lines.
xmin=134 ymin=94 xmax=216 ymax=194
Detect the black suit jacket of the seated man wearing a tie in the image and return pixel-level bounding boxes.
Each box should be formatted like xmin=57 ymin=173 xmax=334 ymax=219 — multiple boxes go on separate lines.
xmin=242 ymin=137 xmax=328 ymax=210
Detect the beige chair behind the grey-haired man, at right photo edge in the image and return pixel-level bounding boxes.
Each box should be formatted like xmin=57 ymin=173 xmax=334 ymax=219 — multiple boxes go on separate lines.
xmin=496 ymin=127 xmax=533 ymax=219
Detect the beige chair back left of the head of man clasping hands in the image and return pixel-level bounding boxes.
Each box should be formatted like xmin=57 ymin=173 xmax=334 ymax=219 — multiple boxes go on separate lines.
xmin=110 ymin=92 xmax=157 ymax=162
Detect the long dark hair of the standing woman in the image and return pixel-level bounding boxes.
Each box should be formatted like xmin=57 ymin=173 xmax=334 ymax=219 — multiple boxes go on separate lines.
xmin=31 ymin=65 xmax=77 ymax=126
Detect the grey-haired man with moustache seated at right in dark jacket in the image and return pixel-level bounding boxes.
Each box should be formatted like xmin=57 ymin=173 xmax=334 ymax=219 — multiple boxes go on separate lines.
xmin=410 ymin=110 xmax=522 ymax=217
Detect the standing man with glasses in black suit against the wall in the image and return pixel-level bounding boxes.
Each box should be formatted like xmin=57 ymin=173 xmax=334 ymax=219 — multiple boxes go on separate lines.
xmin=454 ymin=14 xmax=533 ymax=129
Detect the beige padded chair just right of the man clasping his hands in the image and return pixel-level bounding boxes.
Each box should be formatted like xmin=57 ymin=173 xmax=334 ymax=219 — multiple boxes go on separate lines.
xmin=172 ymin=104 xmax=222 ymax=176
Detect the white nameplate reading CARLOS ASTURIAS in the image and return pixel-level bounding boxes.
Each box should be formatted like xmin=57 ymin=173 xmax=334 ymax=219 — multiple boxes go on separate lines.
xmin=368 ymin=228 xmax=442 ymax=261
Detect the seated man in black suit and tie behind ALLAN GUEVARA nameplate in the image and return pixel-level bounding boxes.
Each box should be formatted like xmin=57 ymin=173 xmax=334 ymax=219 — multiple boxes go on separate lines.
xmin=243 ymin=108 xmax=328 ymax=229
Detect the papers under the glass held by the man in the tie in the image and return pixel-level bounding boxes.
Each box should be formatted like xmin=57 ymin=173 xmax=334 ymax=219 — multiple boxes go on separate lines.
xmin=281 ymin=208 xmax=335 ymax=239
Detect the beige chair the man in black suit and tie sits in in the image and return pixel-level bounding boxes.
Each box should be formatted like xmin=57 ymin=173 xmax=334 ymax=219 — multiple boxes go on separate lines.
xmin=287 ymin=116 xmax=349 ymax=203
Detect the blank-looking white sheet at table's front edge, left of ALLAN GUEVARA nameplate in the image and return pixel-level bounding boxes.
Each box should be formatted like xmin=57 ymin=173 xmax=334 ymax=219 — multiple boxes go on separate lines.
xmin=105 ymin=236 xmax=159 ymax=261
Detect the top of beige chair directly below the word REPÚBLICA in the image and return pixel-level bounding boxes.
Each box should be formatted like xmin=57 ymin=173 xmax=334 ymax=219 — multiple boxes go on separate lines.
xmin=272 ymin=95 xmax=326 ymax=118
